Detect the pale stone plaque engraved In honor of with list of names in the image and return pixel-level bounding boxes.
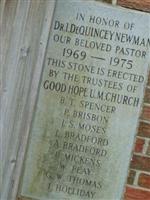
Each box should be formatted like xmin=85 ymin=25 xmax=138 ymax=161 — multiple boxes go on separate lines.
xmin=19 ymin=0 xmax=150 ymax=200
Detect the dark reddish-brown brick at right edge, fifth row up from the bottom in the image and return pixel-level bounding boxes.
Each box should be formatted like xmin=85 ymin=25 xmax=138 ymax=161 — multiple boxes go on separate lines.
xmin=138 ymin=122 xmax=150 ymax=138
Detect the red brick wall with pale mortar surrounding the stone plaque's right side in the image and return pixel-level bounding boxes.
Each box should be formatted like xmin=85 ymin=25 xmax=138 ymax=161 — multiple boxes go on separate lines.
xmin=117 ymin=0 xmax=150 ymax=200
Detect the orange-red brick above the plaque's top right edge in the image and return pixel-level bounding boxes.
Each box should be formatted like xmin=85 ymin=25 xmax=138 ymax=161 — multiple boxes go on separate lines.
xmin=117 ymin=0 xmax=150 ymax=12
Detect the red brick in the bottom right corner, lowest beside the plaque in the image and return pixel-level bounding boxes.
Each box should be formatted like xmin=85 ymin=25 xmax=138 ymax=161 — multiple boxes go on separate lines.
xmin=124 ymin=187 xmax=150 ymax=200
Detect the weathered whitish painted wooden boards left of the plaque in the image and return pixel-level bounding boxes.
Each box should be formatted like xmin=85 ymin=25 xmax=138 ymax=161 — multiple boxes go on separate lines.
xmin=0 ymin=0 xmax=55 ymax=200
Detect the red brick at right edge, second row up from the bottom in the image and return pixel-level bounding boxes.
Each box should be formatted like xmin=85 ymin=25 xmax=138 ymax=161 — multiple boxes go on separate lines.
xmin=138 ymin=173 xmax=150 ymax=189
